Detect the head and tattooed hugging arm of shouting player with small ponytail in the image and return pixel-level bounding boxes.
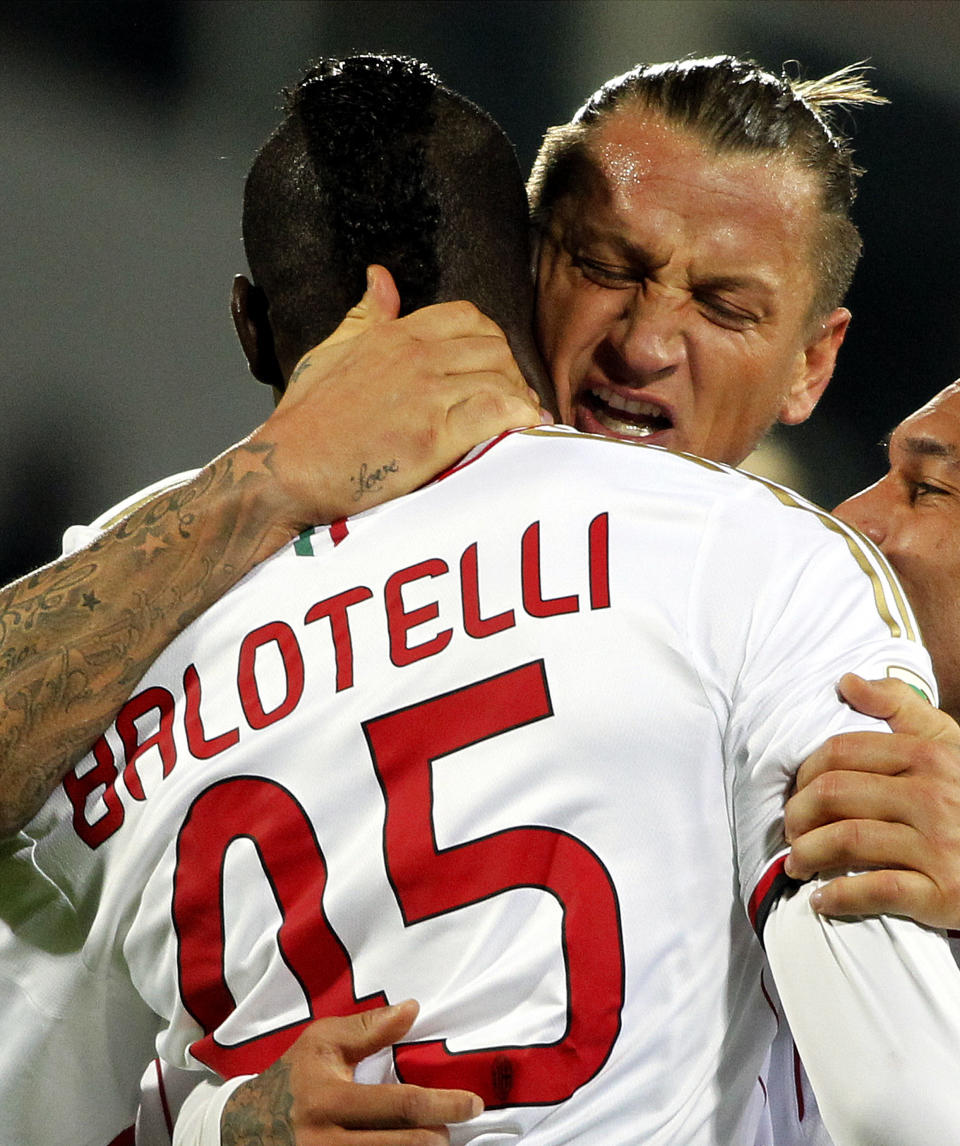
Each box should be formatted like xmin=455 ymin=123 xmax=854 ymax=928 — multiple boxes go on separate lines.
xmin=0 ymin=56 xmax=878 ymax=833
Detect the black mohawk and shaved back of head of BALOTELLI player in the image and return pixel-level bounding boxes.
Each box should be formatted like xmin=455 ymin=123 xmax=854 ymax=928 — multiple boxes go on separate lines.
xmin=243 ymin=55 xmax=532 ymax=375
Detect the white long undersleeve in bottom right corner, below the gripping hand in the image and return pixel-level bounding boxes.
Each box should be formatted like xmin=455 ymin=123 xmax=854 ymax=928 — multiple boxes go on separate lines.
xmin=763 ymin=881 xmax=960 ymax=1146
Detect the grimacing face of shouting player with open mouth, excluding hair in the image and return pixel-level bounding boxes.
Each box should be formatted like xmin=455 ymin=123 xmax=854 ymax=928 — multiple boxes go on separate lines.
xmin=537 ymin=111 xmax=849 ymax=465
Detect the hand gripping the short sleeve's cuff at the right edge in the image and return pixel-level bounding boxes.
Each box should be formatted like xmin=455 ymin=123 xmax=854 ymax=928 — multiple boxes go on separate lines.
xmin=786 ymin=674 xmax=960 ymax=927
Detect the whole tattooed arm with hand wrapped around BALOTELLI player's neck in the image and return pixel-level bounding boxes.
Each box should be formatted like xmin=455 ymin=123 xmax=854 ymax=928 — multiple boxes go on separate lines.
xmin=0 ymin=273 xmax=540 ymax=835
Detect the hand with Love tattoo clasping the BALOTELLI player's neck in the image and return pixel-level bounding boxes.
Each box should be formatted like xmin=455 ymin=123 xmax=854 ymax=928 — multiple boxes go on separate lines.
xmin=241 ymin=266 xmax=541 ymax=547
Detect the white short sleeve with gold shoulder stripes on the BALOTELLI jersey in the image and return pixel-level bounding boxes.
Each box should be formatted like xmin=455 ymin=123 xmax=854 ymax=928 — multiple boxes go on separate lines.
xmin=691 ymin=486 xmax=937 ymax=929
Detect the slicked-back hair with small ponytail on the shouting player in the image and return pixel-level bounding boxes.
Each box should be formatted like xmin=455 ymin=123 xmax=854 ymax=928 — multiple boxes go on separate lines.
xmin=527 ymin=56 xmax=887 ymax=316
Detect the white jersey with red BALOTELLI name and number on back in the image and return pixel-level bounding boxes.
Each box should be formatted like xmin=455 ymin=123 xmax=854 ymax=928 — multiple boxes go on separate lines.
xmin=0 ymin=430 xmax=948 ymax=1146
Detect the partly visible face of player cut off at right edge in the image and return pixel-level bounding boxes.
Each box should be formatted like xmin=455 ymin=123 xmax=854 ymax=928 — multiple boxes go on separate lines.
xmin=834 ymin=383 xmax=960 ymax=717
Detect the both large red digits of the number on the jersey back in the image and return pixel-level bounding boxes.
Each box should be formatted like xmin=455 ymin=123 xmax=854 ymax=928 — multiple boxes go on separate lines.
xmin=172 ymin=661 xmax=624 ymax=1106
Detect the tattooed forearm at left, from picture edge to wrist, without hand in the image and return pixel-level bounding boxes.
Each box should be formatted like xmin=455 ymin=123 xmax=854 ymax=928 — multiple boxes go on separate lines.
xmin=0 ymin=445 xmax=296 ymax=835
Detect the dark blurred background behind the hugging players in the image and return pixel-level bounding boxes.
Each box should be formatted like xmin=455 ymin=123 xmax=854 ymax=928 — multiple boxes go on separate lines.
xmin=0 ymin=0 xmax=960 ymax=583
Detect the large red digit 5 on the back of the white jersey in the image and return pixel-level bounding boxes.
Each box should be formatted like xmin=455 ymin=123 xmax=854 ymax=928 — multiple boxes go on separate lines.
xmin=363 ymin=661 xmax=624 ymax=1107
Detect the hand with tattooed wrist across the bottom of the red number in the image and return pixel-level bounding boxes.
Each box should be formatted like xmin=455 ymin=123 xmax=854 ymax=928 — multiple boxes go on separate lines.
xmin=220 ymin=1000 xmax=483 ymax=1146
